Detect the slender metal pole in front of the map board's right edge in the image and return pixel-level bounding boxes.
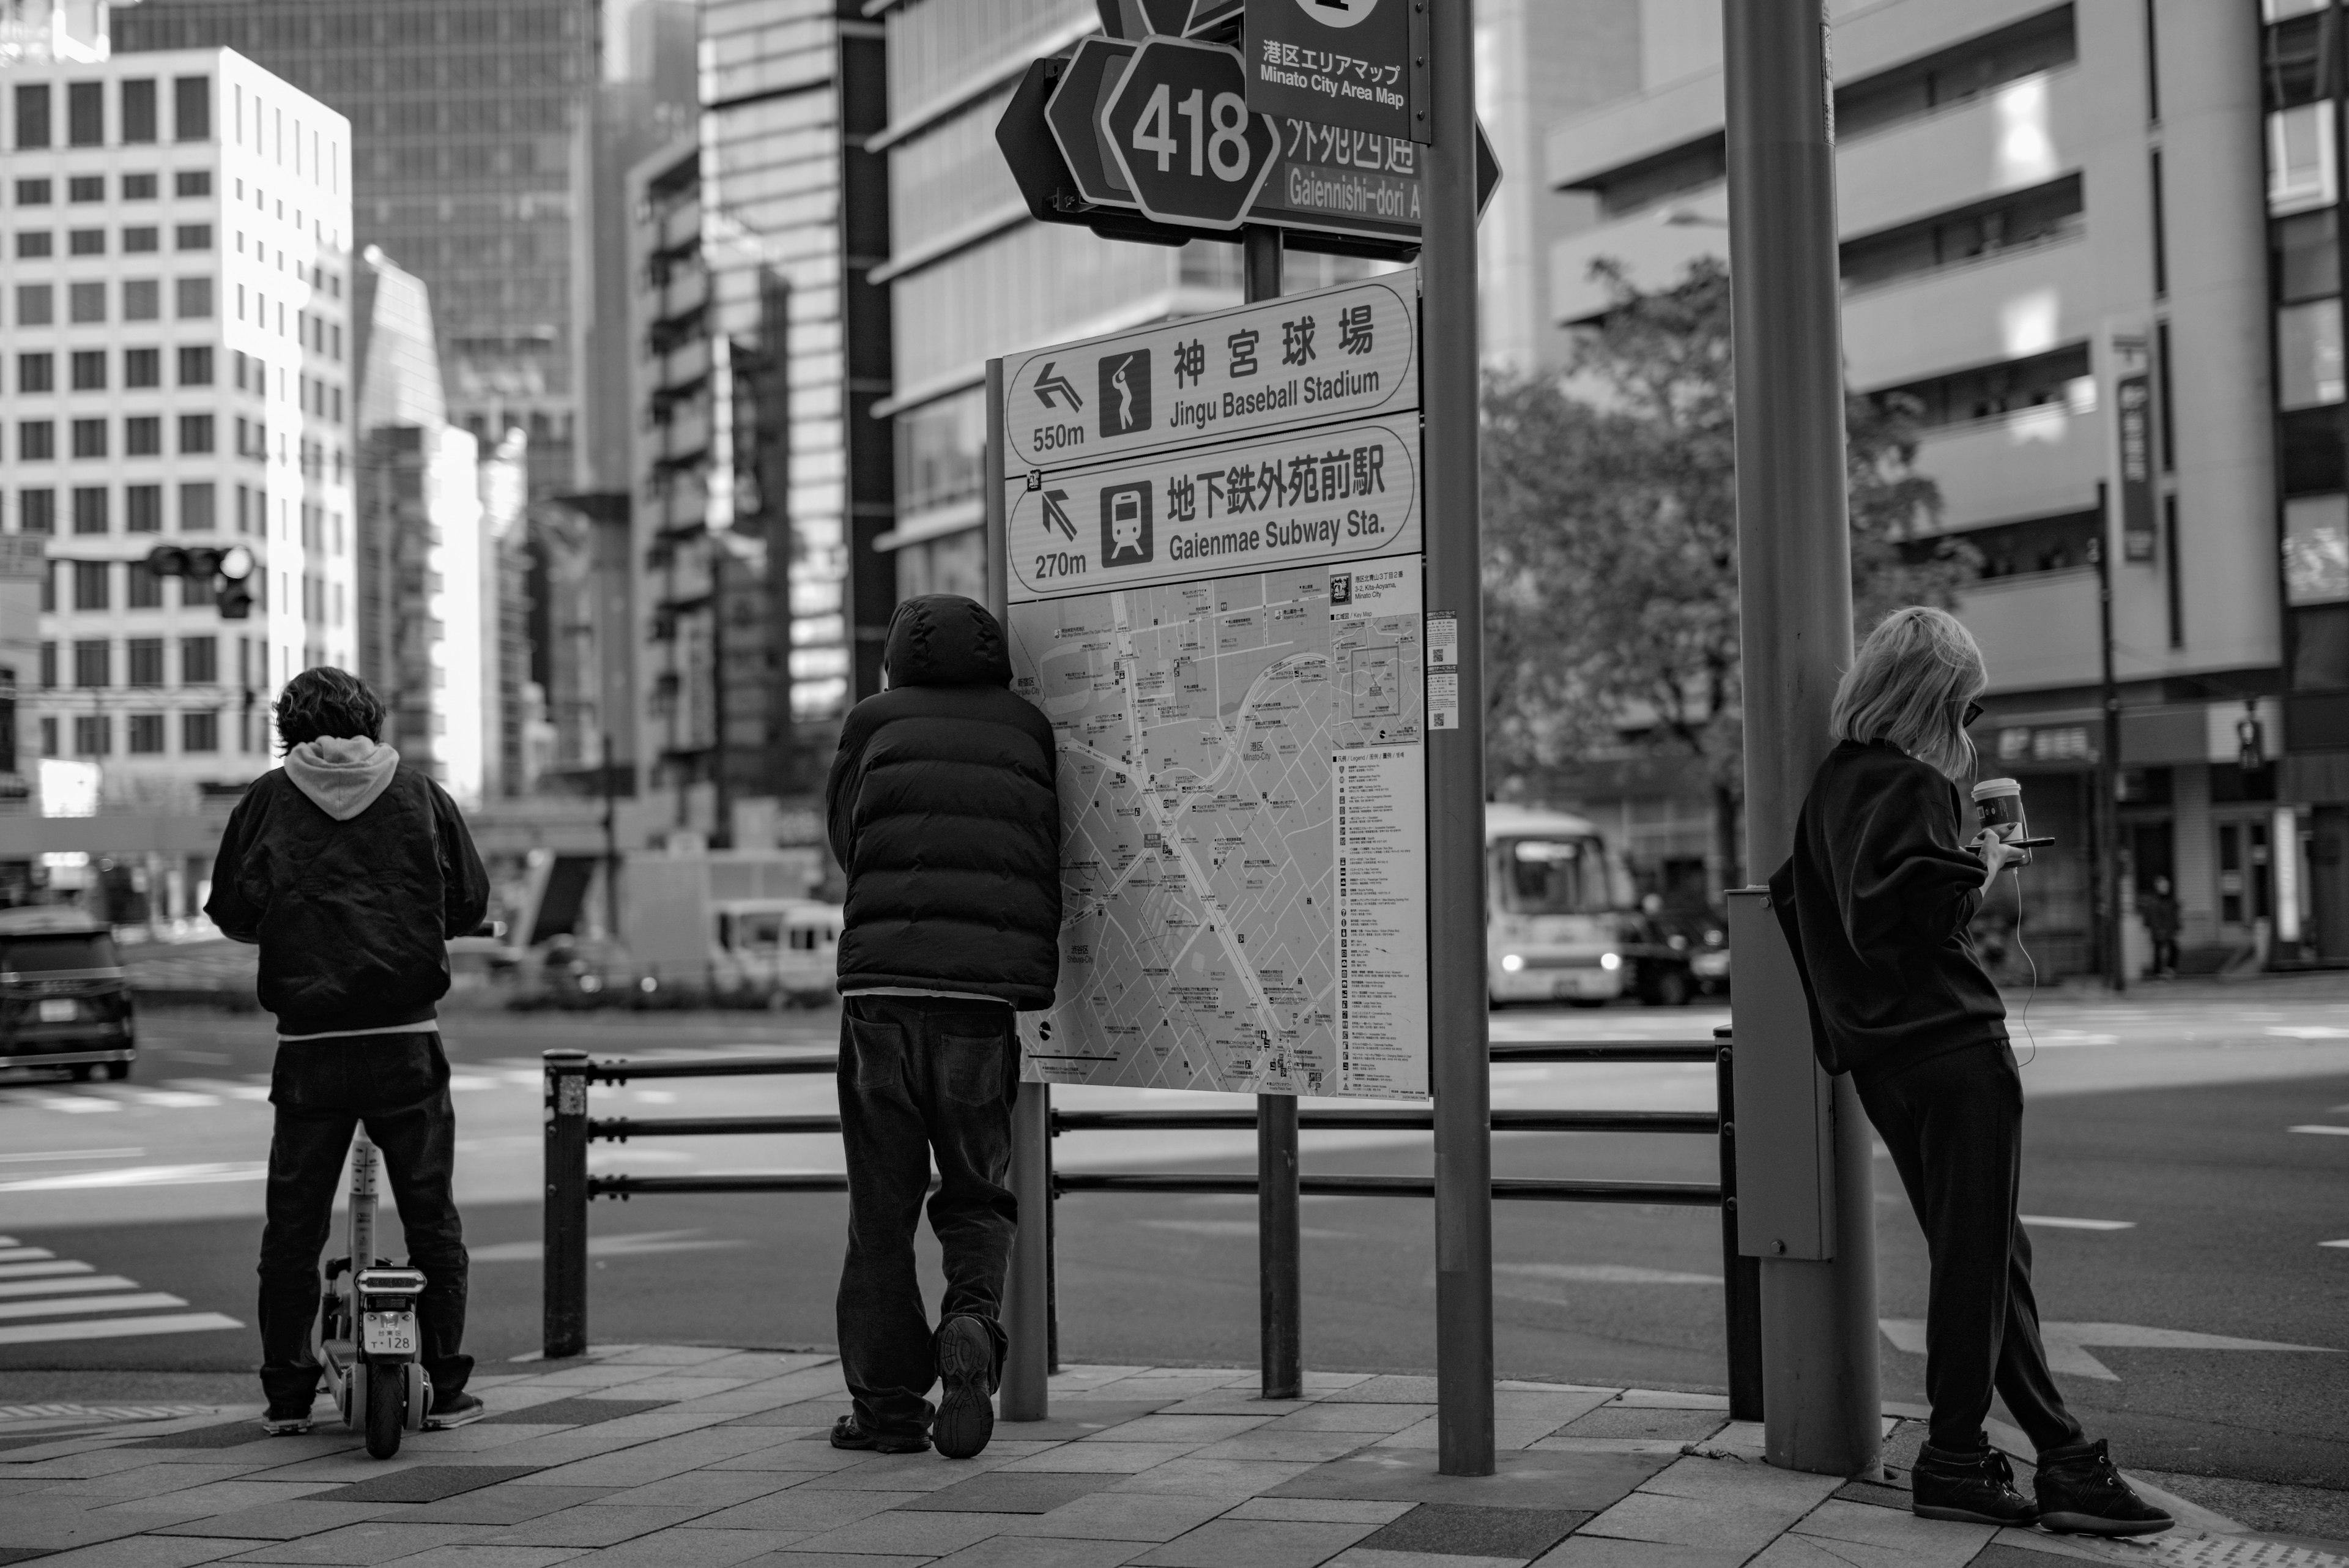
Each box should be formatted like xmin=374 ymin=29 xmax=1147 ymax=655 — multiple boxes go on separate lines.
xmin=1412 ymin=0 xmax=1494 ymax=1476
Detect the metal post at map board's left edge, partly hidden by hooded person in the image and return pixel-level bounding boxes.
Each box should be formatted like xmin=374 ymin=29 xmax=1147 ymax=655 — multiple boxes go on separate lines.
xmin=984 ymin=360 xmax=1052 ymax=1420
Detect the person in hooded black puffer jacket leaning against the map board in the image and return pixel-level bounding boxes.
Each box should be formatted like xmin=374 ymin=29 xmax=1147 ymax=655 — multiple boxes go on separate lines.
xmin=825 ymin=595 xmax=1059 ymax=1457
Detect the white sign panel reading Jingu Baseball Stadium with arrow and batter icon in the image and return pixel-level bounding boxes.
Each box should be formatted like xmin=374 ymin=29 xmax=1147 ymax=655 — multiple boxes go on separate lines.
xmin=1003 ymin=277 xmax=1419 ymax=472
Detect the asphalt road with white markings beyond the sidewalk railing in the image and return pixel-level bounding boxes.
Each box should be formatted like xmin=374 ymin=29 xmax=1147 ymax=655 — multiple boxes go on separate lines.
xmin=0 ymin=980 xmax=2349 ymax=1490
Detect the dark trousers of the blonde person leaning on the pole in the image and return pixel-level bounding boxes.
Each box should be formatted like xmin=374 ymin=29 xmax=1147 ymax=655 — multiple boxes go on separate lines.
xmin=1856 ymin=1044 xmax=2081 ymax=1453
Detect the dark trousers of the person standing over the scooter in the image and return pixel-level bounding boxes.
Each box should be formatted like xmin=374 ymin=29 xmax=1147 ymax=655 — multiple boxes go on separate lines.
xmin=261 ymin=1030 xmax=472 ymax=1406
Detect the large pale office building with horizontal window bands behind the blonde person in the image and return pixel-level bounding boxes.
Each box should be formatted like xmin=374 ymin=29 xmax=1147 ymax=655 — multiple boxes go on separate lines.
xmin=1546 ymin=0 xmax=2349 ymax=971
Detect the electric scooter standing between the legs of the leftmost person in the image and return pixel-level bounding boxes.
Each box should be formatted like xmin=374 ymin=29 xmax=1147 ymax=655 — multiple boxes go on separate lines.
xmin=310 ymin=1142 xmax=432 ymax=1460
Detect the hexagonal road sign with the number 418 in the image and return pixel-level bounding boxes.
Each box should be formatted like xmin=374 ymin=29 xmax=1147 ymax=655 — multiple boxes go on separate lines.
xmin=1102 ymin=37 xmax=1280 ymax=231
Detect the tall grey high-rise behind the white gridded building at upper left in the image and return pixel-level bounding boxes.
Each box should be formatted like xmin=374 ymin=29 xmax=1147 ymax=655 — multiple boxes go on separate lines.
xmin=113 ymin=0 xmax=599 ymax=491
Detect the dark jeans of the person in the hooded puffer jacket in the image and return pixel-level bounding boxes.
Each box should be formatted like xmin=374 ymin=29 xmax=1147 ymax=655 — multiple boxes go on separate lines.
xmin=839 ymin=997 xmax=1020 ymax=1432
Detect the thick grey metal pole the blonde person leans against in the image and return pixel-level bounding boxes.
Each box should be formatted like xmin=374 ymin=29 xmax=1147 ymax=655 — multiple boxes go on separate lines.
xmin=1722 ymin=0 xmax=1882 ymax=1476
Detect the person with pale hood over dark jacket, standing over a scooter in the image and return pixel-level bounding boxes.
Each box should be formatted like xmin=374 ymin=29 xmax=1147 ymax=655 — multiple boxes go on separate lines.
xmin=204 ymin=667 xmax=489 ymax=1434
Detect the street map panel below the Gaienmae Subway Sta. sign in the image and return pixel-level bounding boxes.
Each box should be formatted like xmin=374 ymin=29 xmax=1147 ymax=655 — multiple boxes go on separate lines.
xmin=1010 ymin=567 xmax=1426 ymax=1096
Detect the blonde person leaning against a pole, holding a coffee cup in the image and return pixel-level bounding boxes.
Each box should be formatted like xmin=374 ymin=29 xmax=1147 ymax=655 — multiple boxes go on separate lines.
xmin=1769 ymin=606 xmax=2170 ymax=1535
